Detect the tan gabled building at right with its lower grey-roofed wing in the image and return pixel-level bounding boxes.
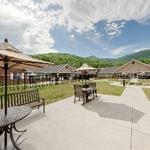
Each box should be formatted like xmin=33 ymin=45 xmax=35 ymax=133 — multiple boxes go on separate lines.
xmin=97 ymin=59 xmax=150 ymax=79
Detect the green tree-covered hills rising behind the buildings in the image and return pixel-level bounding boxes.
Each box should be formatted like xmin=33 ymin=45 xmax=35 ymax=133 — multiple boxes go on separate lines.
xmin=33 ymin=50 xmax=150 ymax=68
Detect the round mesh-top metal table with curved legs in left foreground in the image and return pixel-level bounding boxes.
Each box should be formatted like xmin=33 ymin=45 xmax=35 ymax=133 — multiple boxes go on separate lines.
xmin=0 ymin=106 xmax=32 ymax=150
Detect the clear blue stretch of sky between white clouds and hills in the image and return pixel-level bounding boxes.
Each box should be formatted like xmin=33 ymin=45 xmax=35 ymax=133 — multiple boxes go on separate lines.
xmin=51 ymin=21 xmax=150 ymax=58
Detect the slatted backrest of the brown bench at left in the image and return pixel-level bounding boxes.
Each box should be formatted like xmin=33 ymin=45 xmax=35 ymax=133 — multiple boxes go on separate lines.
xmin=0 ymin=89 xmax=39 ymax=109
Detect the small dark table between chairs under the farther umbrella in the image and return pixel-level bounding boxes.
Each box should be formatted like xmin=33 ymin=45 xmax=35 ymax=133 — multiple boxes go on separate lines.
xmin=82 ymin=87 xmax=95 ymax=105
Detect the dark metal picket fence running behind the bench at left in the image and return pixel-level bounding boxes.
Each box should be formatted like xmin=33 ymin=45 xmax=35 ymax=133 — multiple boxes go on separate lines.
xmin=0 ymin=74 xmax=74 ymax=93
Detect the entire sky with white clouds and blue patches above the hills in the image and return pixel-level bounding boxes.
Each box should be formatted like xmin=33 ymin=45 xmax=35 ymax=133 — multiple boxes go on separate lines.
xmin=0 ymin=0 xmax=150 ymax=58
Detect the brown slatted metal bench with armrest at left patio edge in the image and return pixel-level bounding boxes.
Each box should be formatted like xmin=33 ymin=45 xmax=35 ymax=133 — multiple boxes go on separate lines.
xmin=0 ymin=89 xmax=45 ymax=113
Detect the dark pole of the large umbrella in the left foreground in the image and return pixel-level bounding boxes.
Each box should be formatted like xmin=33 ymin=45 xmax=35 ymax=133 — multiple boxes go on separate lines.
xmin=4 ymin=56 xmax=8 ymax=150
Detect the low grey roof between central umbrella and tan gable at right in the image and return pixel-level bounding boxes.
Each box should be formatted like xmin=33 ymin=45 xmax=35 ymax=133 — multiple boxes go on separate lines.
xmin=97 ymin=67 xmax=118 ymax=74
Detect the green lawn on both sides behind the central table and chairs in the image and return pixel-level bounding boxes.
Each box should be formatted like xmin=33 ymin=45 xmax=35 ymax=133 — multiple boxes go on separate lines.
xmin=0 ymin=81 xmax=124 ymax=103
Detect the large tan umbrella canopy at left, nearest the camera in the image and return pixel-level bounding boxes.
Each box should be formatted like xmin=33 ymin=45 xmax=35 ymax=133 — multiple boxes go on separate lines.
xmin=0 ymin=40 xmax=52 ymax=70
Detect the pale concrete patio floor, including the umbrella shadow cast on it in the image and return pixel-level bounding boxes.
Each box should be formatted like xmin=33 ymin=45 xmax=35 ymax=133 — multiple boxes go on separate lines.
xmin=0 ymin=87 xmax=150 ymax=150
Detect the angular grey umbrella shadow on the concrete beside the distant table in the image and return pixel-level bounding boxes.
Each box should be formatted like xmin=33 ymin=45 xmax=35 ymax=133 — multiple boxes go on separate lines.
xmin=83 ymin=97 xmax=145 ymax=123
